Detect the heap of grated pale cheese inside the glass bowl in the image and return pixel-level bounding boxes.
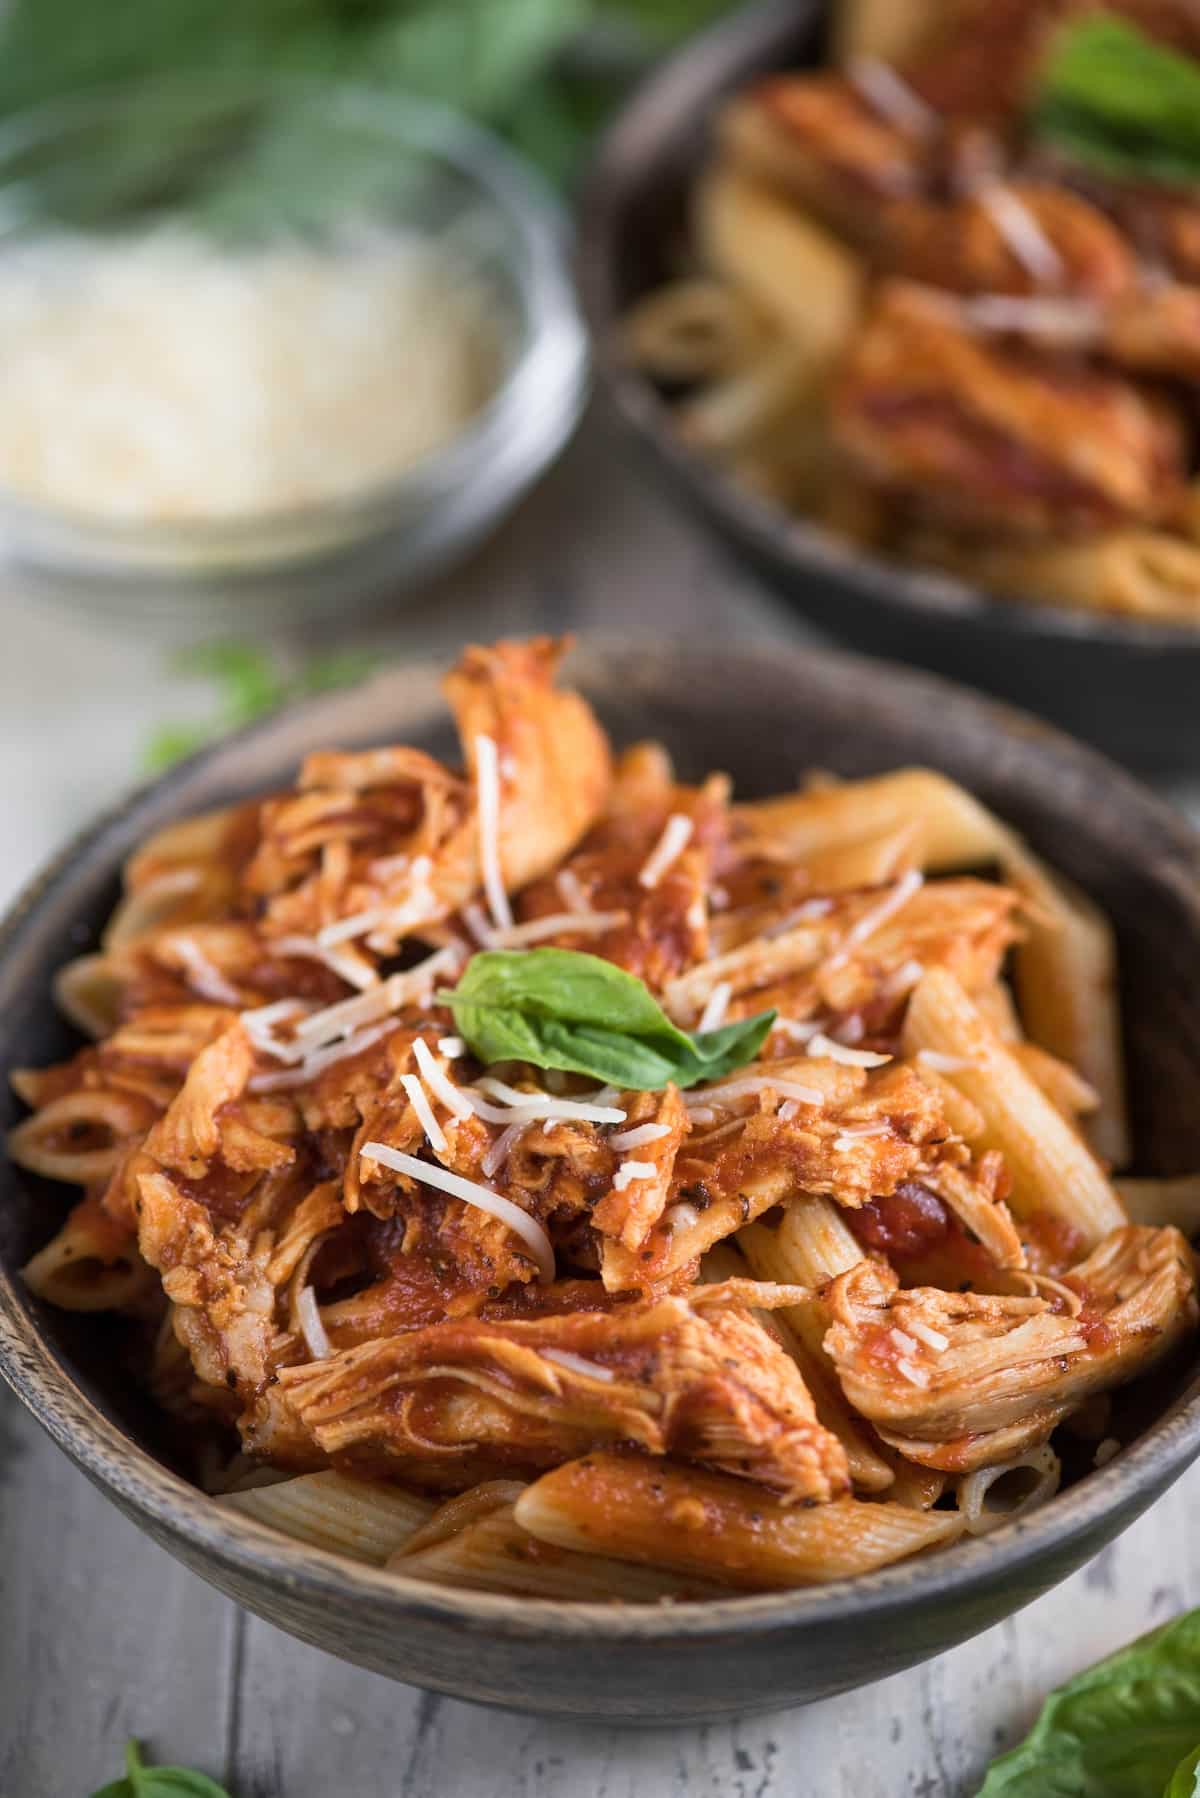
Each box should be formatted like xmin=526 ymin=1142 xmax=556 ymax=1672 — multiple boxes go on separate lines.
xmin=0 ymin=221 xmax=500 ymax=523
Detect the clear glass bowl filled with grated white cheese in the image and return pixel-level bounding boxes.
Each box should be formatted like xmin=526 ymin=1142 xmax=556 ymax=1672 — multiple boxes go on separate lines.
xmin=0 ymin=76 xmax=587 ymax=619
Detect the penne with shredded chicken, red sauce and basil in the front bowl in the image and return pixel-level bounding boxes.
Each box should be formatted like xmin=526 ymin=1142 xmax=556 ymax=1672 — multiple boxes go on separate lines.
xmin=5 ymin=640 xmax=1200 ymax=1713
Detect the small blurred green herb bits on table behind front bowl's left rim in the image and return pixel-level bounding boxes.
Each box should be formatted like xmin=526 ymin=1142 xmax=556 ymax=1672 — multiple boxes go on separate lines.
xmin=142 ymin=638 xmax=374 ymax=773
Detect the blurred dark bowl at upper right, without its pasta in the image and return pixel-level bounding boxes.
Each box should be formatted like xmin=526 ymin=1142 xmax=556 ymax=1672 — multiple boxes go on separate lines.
xmin=579 ymin=0 xmax=1200 ymax=771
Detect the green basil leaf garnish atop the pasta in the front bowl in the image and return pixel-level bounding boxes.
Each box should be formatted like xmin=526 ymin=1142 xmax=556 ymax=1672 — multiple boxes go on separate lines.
xmin=437 ymin=949 xmax=775 ymax=1093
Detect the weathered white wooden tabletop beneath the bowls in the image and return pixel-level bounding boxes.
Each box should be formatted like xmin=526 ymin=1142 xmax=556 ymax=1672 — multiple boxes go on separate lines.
xmin=0 ymin=408 xmax=1200 ymax=1798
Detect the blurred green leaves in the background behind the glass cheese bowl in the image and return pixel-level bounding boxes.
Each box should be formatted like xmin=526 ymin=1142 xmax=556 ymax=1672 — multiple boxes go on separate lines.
xmin=0 ymin=0 xmax=721 ymax=203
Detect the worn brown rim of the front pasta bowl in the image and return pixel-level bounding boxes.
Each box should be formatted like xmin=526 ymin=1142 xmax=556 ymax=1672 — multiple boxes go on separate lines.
xmin=0 ymin=638 xmax=1200 ymax=1643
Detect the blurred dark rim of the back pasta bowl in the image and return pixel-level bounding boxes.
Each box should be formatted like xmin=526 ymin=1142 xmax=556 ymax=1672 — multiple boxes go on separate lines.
xmin=576 ymin=0 xmax=1200 ymax=654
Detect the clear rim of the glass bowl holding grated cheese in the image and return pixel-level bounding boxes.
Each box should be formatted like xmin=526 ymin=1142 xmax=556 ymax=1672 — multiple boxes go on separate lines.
xmin=0 ymin=68 xmax=590 ymax=546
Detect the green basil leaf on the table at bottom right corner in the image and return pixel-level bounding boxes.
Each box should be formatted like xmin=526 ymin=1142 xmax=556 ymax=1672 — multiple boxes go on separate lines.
xmin=979 ymin=1611 xmax=1200 ymax=1798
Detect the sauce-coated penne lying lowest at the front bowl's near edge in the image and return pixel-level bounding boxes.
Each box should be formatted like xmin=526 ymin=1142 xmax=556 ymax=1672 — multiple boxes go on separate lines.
xmin=516 ymin=1455 xmax=963 ymax=1591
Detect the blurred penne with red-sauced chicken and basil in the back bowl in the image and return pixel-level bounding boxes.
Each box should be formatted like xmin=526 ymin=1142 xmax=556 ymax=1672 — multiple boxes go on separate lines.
xmin=626 ymin=0 xmax=1200 ymax=624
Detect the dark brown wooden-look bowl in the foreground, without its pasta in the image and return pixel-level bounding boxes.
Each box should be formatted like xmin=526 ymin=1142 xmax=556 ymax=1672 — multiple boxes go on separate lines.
xmin=0 ymin=647 xmax=1200 ymax=1722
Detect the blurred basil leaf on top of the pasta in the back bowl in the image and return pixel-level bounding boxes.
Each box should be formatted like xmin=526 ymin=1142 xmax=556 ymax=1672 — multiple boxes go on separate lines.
xmin=1033 ymin=13 xmax=1200 ymax=183
